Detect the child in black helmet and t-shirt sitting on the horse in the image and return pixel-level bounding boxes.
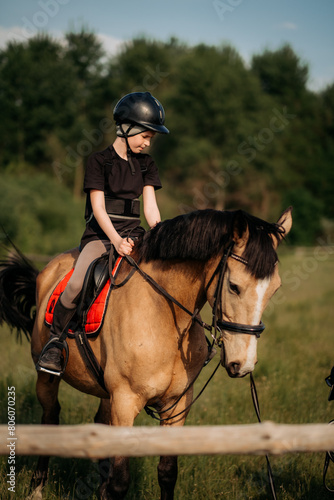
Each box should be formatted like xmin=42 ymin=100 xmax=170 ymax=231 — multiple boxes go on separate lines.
xmin=36 ymin=92 xmax=169 ymax=375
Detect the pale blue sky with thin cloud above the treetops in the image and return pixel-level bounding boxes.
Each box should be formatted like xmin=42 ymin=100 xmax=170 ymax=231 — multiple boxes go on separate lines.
xmin=0 ymin=0 xmax=334 ymax=91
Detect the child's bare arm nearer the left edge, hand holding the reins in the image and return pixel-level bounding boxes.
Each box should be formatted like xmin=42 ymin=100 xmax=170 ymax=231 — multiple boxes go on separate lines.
xmin=90 ymin=189 xmax=134 ymax=257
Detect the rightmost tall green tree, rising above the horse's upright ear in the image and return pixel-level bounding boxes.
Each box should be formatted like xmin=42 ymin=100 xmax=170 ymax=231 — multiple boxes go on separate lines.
xmin=252 ymin=45 xmax=333 ymax=234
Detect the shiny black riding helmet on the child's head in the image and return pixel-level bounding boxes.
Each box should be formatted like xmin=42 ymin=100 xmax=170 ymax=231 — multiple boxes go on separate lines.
xmin=114 ymin=92 xmax=169 ymax=137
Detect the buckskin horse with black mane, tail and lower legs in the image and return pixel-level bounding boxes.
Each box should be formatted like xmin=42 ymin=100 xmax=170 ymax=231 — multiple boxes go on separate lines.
xmin=0 ymin=208 xmax=292 ymax=500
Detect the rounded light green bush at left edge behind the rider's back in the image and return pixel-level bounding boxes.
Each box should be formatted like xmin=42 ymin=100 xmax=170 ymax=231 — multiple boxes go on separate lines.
xmin=0 ymin=173 xmax=84 ymax=255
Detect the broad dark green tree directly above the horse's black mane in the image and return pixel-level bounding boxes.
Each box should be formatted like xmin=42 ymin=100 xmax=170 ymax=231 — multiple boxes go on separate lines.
xmin=160 ymin=45 xmax=280 ymax=215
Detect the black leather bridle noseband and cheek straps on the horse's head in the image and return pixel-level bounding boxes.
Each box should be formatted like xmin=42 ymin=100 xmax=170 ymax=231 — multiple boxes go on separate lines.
xmin=206 ymin=241 xmax=265 ymax=344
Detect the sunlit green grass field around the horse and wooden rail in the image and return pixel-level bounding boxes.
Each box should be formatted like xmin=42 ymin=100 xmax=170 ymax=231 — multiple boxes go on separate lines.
xmin=0 ymin=248 xmax=334 ymax=500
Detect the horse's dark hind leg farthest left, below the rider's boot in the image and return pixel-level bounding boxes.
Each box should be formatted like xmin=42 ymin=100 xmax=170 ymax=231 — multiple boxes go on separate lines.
xmin=30 ymin=372 xmax=60 ymax=490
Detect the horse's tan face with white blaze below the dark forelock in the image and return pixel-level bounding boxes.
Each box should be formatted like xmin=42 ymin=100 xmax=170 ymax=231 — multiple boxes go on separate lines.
xmin=222 ymin=259 xmax=280 ymax=377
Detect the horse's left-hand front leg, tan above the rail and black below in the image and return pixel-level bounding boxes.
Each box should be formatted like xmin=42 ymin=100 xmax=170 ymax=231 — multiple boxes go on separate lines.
xmin=100 ymin=391 xmax=141 ymax=500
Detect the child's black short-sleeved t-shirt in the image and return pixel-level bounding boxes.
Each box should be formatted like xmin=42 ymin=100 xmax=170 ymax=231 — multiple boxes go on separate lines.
xmin=81 ymin=146 xmax=161 ymax=248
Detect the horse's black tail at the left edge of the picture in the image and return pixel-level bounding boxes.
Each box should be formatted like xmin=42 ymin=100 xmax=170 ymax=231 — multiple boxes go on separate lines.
xmin=0 ymin=242 xmax=38 ymax=340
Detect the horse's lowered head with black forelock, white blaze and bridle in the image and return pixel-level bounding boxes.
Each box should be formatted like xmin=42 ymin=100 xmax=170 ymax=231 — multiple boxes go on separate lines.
xmin=208 ymin=209 xmax=292 ymax=377
